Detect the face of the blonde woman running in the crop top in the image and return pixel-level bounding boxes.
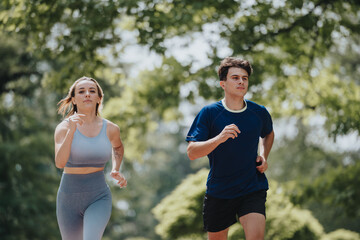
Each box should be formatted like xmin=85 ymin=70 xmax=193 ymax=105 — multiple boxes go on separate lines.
xmin=72 ymin=80 xmax=101 ymax=110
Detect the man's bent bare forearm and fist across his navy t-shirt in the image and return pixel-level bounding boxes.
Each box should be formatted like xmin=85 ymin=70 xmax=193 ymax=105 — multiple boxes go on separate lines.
xmin=187 ymin=124 xmax=240 ymax=160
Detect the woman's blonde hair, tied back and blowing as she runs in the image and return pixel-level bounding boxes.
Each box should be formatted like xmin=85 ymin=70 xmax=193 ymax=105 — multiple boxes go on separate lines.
xmin=58 ymin=76 xmax=104 ymax=118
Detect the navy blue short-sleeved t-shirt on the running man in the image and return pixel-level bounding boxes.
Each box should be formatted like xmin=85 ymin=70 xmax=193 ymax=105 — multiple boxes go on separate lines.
xmin=186 ymin=100 xmax=273 ymax=199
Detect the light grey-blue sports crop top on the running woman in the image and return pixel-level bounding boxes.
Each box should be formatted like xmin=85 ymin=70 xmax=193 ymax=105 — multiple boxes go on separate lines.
xmin=66 ymin=119 xmax=112 ymax=167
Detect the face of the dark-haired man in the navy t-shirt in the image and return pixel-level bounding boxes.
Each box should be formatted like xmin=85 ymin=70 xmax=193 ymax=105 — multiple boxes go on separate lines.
xmin=220 ymin=67 xmax=249 ymax=97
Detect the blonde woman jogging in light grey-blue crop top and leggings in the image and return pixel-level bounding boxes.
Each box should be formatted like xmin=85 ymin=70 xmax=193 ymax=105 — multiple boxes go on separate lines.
xmin=55 ymin=77 xmax=127 ymax=240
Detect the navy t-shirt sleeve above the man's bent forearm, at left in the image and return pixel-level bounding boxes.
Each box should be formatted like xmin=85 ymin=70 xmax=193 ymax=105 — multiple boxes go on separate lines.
xmin=186 ymin=108 xmax=210 ymax=142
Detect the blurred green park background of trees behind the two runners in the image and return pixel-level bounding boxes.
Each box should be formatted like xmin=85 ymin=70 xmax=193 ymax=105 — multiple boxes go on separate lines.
xmin=0 ymin=0 xmax=360 ymax=240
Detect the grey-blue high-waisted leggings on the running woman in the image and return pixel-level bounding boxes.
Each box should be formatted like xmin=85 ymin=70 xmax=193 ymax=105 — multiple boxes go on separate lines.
xmin=56 ymin=171 xmax=112 ymax=240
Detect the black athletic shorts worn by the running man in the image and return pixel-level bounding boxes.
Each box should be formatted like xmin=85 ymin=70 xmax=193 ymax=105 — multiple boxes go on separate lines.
xmin=203 ymin=190 xmax=267 ymax=232
